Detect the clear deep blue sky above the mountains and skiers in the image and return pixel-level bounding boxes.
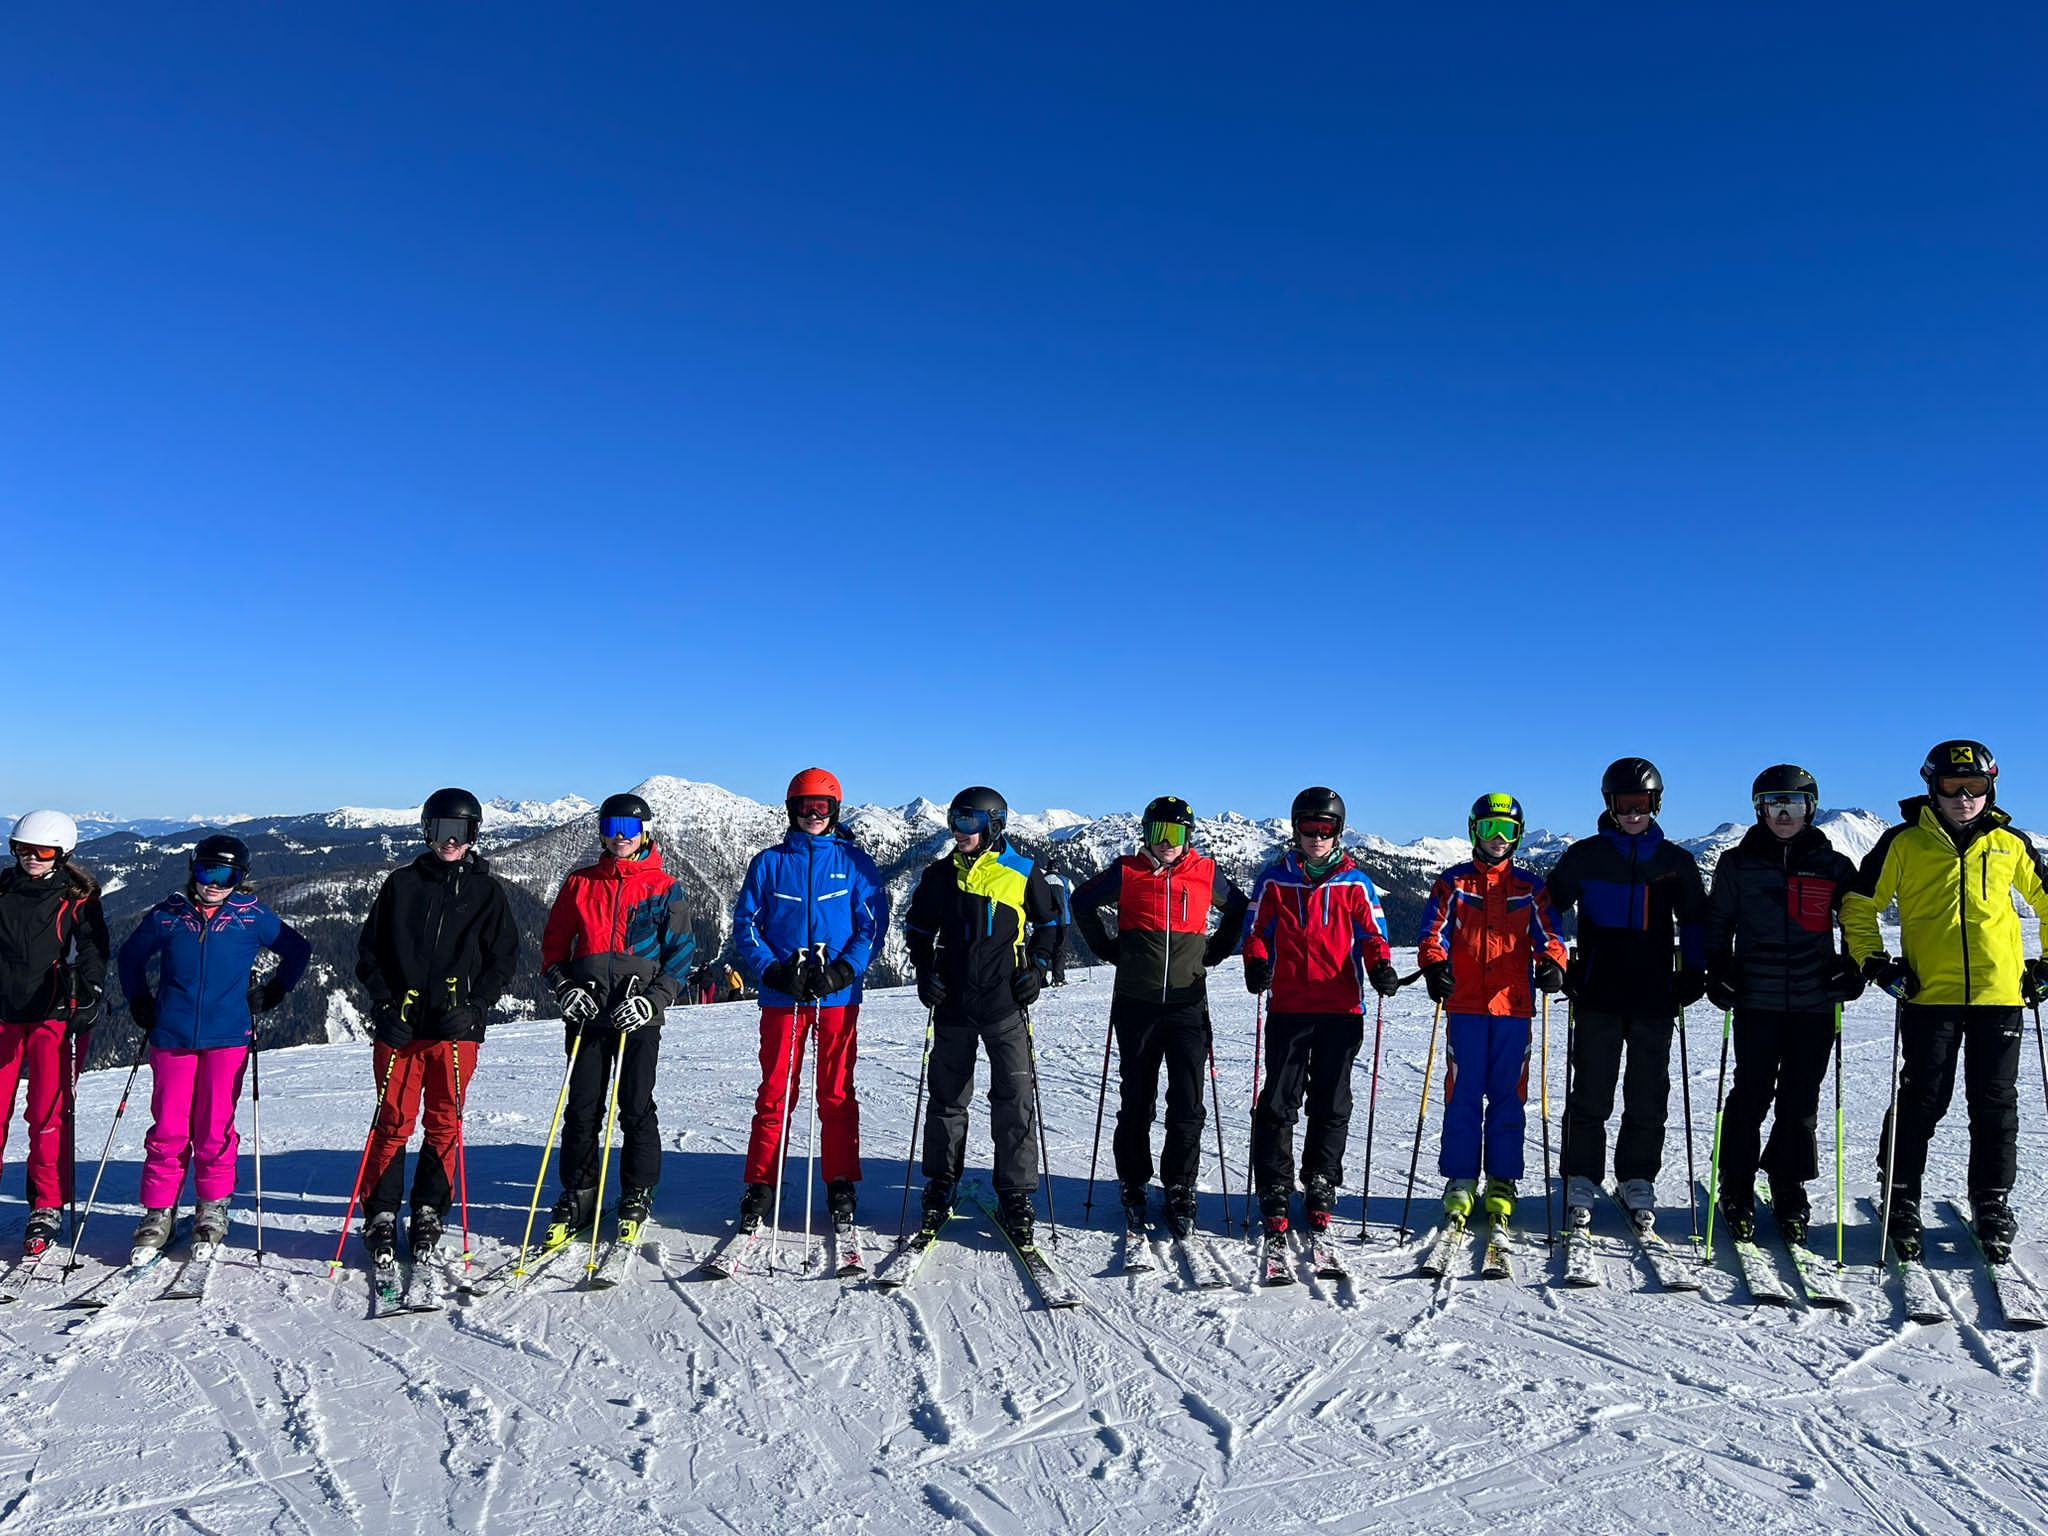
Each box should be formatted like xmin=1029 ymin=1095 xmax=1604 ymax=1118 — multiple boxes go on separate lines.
xmin=0 ymin=4 xmax=2048 ymax=838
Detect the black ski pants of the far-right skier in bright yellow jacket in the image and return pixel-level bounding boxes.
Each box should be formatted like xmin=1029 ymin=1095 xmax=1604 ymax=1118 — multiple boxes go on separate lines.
xmin=1878 ymin=1004 xmax=2023 ymax=1204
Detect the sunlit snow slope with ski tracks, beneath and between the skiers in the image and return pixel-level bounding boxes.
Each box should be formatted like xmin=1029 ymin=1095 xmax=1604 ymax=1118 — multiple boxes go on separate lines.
xmin=0 ymin=967 xmax=2048 ymax=1536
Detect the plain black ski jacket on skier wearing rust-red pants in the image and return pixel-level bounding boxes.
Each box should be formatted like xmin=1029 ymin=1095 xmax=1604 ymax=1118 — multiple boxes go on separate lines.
xmin=356 ymin=850 xmax=518 ymax=1044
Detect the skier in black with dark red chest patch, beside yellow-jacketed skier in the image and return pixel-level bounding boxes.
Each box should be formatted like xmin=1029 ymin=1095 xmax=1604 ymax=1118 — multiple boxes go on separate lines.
xmin=1706 ymin=762 xmax=1864 ymax=1243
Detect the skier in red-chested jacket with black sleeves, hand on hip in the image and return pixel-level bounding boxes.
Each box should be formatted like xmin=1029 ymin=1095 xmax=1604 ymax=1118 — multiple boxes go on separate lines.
xmin=1073 ymin=795 xmax=1249 ymax=1237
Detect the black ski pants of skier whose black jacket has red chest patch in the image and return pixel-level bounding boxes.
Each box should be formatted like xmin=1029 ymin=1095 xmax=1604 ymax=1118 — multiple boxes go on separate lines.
xmin=1720 ymin=1008 xmax=1835 ymax=1200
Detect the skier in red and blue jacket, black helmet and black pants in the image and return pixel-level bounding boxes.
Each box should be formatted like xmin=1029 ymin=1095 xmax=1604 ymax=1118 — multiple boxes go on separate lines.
xmin=1245 ymin=784 xmax=1401 ymax=1239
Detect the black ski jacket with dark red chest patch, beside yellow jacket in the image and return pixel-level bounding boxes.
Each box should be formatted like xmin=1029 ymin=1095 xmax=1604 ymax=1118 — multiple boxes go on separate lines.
xmin=1706 ymin=827 xmax=1864 ymax=1014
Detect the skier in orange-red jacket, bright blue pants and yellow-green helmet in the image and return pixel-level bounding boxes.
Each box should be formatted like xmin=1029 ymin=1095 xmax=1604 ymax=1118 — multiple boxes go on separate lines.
xmin=1415 ymin=795 xmax=1569 ymax=1221
